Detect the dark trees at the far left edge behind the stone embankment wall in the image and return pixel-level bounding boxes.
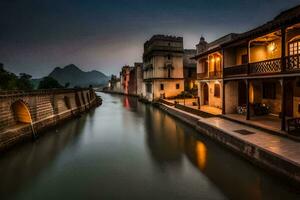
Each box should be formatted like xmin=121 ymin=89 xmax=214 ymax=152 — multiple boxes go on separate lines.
xmin=0 ymin=63 xmax=33 ymax=90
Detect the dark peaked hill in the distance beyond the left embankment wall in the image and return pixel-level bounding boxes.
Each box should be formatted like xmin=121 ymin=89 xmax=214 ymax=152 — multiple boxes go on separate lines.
xmin=33 ymin=64 xmax=109 ymax=87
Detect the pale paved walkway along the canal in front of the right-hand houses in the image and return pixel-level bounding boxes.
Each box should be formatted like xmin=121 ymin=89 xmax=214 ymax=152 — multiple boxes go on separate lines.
xmin=163 ymin=104 xmax=300 ymax=167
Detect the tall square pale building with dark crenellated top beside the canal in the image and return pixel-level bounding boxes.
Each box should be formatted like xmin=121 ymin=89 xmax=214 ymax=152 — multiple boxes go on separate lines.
xmin=143 ymin=35 xmax=184 ymax=101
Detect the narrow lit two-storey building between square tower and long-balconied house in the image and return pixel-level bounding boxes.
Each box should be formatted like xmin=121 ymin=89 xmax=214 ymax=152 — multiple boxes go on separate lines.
xmin=193 ymin=33 xmax=237 ymax=114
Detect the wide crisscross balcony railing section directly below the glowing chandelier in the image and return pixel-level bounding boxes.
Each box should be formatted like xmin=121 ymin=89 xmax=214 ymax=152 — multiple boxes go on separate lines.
xmin=249 ymin=58 xmax=281 ymax=74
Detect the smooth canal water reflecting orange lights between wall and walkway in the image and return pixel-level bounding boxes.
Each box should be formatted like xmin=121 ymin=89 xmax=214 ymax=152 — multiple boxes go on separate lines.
xmin=0 ymin=93 xmax=300 ymax=200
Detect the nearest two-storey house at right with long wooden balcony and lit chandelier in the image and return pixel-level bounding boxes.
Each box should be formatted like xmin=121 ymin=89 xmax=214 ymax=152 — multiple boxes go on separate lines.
xmin=222 ymin=6 xmax=300 ymax=131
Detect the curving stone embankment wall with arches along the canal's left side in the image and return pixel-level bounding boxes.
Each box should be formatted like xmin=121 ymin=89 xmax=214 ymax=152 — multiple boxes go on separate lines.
xmin=0 ymin=89 xmax=101 ymax=151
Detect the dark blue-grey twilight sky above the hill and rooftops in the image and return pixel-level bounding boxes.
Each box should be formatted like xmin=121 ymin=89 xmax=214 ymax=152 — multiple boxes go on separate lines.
xmin=0 ymin=0 xmax=300 ymax=77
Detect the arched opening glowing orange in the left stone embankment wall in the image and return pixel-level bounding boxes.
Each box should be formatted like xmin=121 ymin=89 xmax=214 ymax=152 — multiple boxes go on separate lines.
xmin=11 ymin=100 xmax=32 ymax=124
